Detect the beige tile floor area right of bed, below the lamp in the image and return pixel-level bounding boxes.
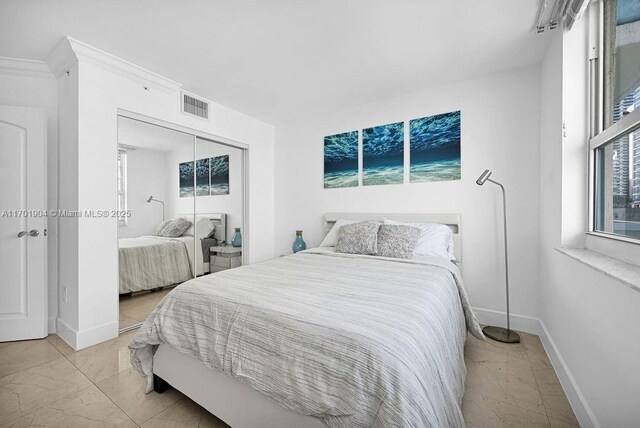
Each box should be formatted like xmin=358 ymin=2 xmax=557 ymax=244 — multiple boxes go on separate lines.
xmin=462 ymin=333 xmax=579 ymax=428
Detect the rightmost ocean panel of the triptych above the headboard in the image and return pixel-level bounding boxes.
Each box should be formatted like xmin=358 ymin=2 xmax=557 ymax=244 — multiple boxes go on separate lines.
xmin=409 ymin=111 xmax=462 ymax=183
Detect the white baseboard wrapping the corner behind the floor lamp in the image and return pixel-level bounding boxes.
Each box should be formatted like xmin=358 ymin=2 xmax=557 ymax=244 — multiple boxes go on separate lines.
xmin=473 ymin=308 xmax=600 ymax=428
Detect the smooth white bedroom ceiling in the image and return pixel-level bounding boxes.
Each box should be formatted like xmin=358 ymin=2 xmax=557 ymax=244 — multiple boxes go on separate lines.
xmin=0 ymin=0 xmax=559 ymax=124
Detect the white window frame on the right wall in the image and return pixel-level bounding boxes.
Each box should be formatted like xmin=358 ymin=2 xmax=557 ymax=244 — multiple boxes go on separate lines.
xmin=587 ymin=0 xmax=640 ymax=246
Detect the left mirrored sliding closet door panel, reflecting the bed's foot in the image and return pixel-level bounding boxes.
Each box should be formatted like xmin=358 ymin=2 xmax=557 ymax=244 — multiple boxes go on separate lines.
xmin=117 ymin=116 xmax=194 ymax=330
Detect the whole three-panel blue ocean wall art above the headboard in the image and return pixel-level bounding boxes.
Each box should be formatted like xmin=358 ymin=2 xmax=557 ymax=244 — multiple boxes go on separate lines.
xmin=324 ymin=111 xmax=461 ymax=189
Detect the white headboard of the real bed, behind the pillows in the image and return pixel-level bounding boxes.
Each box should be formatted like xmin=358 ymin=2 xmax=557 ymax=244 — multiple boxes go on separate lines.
xmin=322 ymin=213 xmax=462 ymax=262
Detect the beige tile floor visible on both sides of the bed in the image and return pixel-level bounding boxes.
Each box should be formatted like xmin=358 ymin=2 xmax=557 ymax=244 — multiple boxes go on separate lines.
xmin=0 ymin=330 xmax=578 ymax=428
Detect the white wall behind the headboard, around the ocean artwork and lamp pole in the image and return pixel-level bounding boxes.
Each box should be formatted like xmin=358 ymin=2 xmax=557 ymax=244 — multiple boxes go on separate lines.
xmin=276 ymin=67 xmax=540 ymax=316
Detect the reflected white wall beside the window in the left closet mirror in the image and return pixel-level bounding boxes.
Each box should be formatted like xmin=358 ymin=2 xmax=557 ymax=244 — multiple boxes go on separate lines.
xmin=118 ymin=148 xmax=166 ymax=238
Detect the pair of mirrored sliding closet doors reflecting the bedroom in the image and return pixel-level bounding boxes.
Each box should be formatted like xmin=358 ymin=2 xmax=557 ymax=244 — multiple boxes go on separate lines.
xmin=117 ymin=116 xmax=244 ymax=331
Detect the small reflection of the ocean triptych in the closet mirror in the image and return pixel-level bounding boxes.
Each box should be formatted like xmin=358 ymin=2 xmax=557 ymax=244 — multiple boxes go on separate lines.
xmin=179 ymin=155 xmax=229 ymax=198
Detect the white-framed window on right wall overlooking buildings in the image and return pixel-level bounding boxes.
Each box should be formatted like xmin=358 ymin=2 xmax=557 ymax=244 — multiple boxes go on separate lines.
xmin=590 ymin=0 xmax=640 ymax=243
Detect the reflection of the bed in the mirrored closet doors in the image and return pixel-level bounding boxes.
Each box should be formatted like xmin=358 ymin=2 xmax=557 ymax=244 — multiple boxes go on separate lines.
xmin=118 ymin=213 xmax=227 ymax=294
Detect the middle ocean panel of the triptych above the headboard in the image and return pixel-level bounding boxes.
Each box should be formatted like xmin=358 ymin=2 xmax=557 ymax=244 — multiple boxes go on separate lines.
xmin=362 ymin=122 xmax=404 ymax=186
